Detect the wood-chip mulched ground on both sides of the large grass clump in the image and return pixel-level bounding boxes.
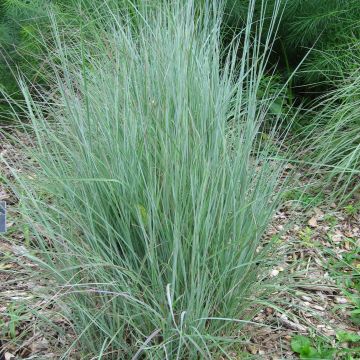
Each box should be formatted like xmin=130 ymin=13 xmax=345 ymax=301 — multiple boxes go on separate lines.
xmin=0 ymin=135 xmax=360 ymax=360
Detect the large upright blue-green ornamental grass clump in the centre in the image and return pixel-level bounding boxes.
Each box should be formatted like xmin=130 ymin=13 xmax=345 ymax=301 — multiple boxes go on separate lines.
xmin=9 ymin=0 xmax=290 ymax=359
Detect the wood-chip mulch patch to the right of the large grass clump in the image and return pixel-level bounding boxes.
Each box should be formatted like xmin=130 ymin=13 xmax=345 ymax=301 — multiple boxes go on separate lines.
xmin=243 ymin=198 xmax=360 ymax=360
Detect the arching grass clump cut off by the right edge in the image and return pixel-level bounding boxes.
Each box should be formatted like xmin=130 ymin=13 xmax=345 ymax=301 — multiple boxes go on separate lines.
xmin=303 ymin=70 xmax=360 ymax=202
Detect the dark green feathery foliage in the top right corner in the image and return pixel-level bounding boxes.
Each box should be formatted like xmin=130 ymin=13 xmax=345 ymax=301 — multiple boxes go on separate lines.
xmin=227 ymin=0 xmax=360 ymax=85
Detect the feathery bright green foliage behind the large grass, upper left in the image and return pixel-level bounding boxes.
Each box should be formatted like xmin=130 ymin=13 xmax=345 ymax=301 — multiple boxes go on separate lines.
xmin=0 ymin=0 xmax=142 ymax=124
